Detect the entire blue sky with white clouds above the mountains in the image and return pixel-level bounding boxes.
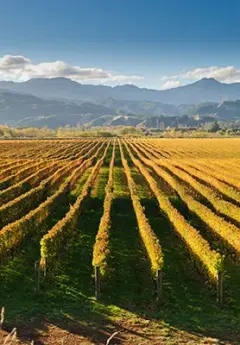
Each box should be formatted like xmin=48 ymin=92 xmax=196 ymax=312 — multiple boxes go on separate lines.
xmin=0 ymin=0 xmax=240 ymax=89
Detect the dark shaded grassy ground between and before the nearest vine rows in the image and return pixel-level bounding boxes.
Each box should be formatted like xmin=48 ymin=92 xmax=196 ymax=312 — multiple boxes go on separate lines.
xmin=0 ymin=198 xmax=240 ymax=345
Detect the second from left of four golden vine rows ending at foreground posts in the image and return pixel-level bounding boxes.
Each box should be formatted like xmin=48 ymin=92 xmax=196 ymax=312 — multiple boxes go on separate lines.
xmin=92 ymin=138 xmax=115 ymax=278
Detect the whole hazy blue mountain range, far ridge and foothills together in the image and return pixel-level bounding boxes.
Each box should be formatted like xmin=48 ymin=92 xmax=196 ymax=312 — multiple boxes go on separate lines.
xmin=0 ymin=78 xmax=240 ymax=128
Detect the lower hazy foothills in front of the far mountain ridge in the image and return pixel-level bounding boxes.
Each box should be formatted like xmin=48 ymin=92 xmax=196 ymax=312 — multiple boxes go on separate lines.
xmin=0 ymin=90 xmax=240 ymax=128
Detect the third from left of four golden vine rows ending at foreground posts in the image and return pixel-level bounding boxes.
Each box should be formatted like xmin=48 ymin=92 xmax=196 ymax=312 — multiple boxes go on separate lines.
xmin=119 ymin=142 xmax=164 ymax=276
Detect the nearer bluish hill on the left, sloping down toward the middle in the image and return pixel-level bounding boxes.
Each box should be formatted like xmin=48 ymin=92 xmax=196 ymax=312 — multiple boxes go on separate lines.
xmin=0 ymin=90 xmax=115 ymax=127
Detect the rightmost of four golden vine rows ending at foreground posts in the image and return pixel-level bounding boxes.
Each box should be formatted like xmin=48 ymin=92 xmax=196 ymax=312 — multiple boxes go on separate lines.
xmin=126 ymin=140 xmax=223 ymax=285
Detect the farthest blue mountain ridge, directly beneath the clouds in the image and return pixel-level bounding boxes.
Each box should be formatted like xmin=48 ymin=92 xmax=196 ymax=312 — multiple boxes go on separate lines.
xmin=3 ymin=78 xmax=240 ymax=105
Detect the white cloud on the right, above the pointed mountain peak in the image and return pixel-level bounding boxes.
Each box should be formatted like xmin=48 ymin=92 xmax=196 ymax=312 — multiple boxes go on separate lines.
xmin=161 ymin=66 xmax=240 ymax=83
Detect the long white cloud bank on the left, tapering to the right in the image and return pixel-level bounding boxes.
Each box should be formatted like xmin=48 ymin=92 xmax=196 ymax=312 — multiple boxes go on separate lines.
xmin=0 ymin=55 xmax=143 ymax=83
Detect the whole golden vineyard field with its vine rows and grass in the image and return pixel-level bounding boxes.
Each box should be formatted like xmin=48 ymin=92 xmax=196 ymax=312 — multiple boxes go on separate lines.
xmin=0 ymin=138 xmax=240 ymax=345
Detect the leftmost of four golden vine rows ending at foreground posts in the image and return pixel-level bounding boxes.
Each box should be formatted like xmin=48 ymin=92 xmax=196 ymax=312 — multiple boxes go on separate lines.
xmin=40 ymin=144 xmax=109 ymax=266
